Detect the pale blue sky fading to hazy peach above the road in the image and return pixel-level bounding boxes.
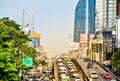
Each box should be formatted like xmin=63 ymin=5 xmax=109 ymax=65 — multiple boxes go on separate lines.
xmin=0 ymin=0 xmax=79 ymax=54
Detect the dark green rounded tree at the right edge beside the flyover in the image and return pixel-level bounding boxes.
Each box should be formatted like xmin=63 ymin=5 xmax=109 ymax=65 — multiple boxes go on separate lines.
xmin=111 ymin=49 xmax=120 ymax=71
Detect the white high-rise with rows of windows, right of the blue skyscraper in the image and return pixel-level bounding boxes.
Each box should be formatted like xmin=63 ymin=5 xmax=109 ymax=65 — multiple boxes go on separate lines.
xmin=96 ymin=0 xmax=116 ymax=29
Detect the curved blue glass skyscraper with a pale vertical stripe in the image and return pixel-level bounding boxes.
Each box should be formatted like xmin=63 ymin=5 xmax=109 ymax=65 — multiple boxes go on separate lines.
xmin=74 ymin=0 xmax=96 ymax=42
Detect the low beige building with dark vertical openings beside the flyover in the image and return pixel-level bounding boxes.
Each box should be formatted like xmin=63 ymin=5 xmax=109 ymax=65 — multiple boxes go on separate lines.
xmin=88 ymin=38 xmax=103 ymax=62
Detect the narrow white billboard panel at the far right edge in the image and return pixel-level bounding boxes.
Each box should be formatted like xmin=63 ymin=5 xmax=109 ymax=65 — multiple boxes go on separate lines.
xmin=116 ymin=18 xmax=120 ymax=48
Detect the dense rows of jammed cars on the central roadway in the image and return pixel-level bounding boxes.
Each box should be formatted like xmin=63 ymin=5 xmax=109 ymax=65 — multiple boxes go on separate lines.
xmin=56 ymin=57 xmax=81 ymax=81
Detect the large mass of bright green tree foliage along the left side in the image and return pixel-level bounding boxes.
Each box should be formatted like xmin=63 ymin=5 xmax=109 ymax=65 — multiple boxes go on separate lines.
xmin=0 ymin=17 xmax=36 ymax=81
